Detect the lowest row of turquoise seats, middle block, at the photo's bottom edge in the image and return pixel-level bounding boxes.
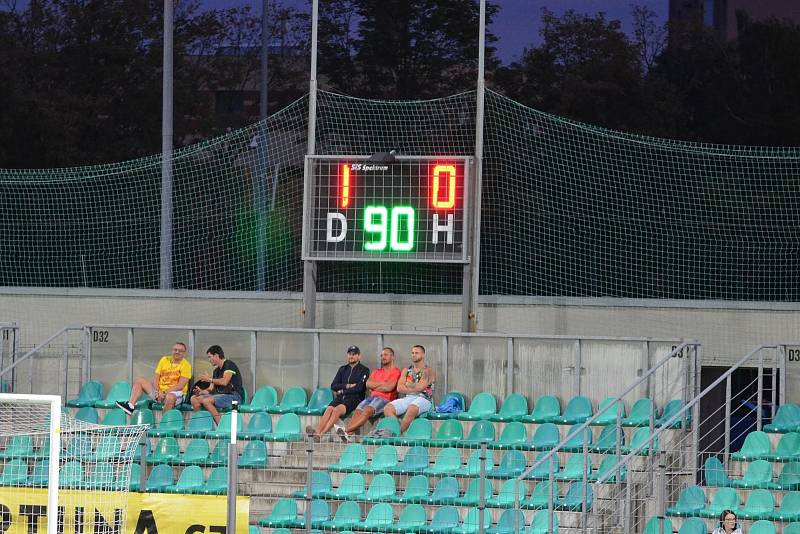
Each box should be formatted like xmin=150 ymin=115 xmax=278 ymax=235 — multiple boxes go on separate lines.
xmin=259 ymin=499 xmax=558 ymax=534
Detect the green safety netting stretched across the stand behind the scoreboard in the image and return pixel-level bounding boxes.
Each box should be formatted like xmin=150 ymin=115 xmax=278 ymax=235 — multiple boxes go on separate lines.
xmin=0 ymin=92 xmax=800 ymax=301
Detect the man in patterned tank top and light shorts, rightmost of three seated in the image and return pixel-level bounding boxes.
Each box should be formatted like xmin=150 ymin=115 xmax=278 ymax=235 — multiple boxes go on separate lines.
xmin=383 ymin=345 xmax=436 ymax=432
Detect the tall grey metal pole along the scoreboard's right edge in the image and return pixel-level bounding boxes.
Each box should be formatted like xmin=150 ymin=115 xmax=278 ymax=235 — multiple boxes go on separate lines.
xmin=461 ymin=0 xmax=486 ymax=332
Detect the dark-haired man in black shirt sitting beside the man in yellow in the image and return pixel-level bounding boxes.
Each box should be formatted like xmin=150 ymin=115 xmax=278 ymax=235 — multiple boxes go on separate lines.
xmin=192 ymin=345 xmax=243 ymax=424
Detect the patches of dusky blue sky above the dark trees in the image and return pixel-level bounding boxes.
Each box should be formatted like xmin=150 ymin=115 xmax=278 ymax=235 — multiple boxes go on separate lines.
xmin=202 ymin=0 xmax=669 ymax=63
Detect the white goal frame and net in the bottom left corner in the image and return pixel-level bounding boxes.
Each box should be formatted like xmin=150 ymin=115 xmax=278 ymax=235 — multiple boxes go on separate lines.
xmin=0 ymin=394 xmax=147 ymax=534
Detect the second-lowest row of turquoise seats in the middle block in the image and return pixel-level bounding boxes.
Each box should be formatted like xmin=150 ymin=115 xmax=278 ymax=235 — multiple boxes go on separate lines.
xmin=293 ymin=471 xmax=593 ymax=510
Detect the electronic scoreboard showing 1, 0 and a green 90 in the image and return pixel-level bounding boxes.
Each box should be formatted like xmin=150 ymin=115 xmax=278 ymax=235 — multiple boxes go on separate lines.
xmin=303 ymin=156 xmax=472 ymax=263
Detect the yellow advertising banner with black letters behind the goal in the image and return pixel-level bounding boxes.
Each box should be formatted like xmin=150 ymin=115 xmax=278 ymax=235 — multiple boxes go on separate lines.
xmin=0 ymin=487 xmax=250 ymax=534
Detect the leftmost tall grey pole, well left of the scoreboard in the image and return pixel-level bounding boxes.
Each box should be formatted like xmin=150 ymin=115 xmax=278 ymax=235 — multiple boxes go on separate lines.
xmin=159 ymin=0 xmax=174 ymax=289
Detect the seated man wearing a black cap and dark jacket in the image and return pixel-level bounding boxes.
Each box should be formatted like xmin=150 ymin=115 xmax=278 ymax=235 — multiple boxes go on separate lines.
xmin=306 ymin=345 xmax=369 ymax=437
